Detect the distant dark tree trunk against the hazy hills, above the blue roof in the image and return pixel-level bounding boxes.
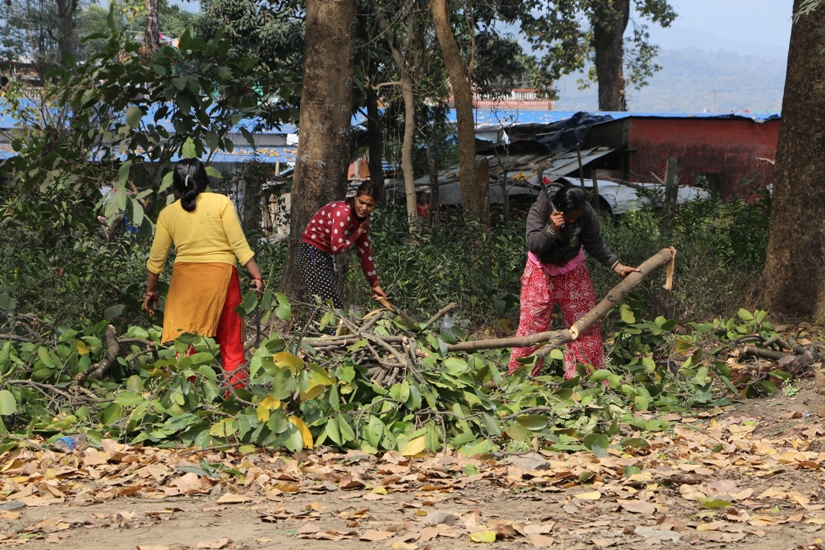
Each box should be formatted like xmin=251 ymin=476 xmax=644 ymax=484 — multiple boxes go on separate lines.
xmin=593 ymin=0 xmax=630 ymax=111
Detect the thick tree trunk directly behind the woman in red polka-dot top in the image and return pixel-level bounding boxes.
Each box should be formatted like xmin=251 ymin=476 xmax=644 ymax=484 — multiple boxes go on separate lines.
xmin=280 ymin=0 xmax=355 ymax=298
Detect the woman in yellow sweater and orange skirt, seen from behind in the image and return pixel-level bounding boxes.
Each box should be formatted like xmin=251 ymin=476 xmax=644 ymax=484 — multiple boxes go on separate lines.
xmin=143 ymin=159 xmax=263 ymax=388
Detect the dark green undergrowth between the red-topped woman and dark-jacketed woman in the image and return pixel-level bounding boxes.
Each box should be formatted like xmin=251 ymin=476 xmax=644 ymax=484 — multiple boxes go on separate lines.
xmin=346 ymin=205 xmax=526 ymax=324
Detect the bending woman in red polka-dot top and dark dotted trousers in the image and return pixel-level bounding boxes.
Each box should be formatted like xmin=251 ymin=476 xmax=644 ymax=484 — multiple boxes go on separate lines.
xmin=298 ymin=181 xmax=387 ymax=308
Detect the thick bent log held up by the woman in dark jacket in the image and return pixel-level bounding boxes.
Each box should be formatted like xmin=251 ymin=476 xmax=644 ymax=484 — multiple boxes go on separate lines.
xmin=447 ymin=247 xmax=676 ymax=351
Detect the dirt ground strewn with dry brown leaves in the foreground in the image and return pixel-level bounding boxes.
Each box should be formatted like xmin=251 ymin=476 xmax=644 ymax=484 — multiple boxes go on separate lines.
xmin=0 ymin=382 xmax=825 ymax=550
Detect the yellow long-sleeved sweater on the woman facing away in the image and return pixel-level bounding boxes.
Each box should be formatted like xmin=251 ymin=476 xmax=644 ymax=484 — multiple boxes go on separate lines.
xmin=146 ymin=193 xmax=255 ymax=274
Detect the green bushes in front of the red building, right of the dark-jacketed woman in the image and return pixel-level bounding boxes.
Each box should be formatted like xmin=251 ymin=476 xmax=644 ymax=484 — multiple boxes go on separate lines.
xmin=589 ymin=197 xmax=770 ymax=321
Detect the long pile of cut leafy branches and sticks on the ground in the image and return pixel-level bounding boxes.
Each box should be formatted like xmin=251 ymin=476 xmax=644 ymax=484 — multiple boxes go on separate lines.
xmin=0 ymin=250 xmax=822 ymax=456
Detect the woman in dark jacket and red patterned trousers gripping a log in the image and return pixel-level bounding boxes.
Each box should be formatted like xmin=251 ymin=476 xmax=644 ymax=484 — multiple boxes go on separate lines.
xmin=509 ymin=183 xmax=639 ymax=378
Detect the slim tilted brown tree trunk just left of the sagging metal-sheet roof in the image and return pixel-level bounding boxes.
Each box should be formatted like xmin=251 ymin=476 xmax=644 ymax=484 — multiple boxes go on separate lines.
xmin=430 ymin=0 xmax=490 ymax=226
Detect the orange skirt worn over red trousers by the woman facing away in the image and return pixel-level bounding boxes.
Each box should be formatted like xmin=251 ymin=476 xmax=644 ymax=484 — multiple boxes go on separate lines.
xmin=161 ymin=262 xmax=234 ymax=343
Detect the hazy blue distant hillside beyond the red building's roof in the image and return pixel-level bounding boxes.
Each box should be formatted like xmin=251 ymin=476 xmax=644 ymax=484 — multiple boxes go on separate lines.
xmin=556 ymin=48 xmax=786 ymax=113
